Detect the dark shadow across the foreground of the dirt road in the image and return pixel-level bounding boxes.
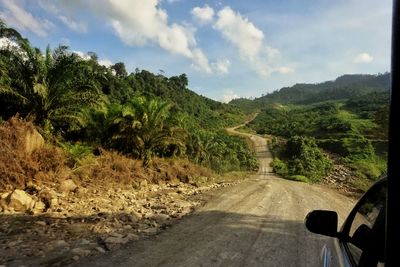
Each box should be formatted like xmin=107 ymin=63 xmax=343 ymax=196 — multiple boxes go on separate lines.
xmin=74 ymin=211 xmax=326 ymax=266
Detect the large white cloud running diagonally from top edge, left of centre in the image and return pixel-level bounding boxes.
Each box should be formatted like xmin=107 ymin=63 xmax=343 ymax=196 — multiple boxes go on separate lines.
xmin=64 ymin=0 xmax=212 ymax=73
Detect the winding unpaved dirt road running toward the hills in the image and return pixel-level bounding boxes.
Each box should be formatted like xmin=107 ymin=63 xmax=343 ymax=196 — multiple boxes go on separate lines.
xmin=80 ymin=129 xmax=353 ymax=267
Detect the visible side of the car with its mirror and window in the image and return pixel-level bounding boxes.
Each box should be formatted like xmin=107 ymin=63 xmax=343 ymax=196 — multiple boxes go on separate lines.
xmin=305 ymin=178 xmax=387 ymax=267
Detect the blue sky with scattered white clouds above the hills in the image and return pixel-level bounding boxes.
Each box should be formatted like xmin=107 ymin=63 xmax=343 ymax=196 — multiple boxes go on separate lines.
xmin=0 ymin=0 xmax=392 ymax=102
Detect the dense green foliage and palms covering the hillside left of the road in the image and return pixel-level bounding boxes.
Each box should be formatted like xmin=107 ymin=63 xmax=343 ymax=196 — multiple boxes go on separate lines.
xmin=0 ymin=21 xmax=257 ymax=176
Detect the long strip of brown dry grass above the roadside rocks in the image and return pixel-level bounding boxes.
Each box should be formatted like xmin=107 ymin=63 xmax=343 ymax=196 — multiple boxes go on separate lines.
xmin=0 ymin=117 xmax=214 ymax=192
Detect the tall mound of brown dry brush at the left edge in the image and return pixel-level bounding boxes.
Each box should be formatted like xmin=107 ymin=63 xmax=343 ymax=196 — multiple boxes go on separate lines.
xmin=0 ymin=117 xmax=65 ymax=191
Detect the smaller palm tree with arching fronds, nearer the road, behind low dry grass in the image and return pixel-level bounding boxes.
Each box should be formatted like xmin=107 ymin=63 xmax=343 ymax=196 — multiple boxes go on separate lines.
xmin=108 ymin=97 xmax=185 ymax=166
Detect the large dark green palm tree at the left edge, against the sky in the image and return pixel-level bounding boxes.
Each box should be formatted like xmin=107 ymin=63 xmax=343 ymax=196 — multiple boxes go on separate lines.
xmin=0 ymin=23 xmax=102 ymax=133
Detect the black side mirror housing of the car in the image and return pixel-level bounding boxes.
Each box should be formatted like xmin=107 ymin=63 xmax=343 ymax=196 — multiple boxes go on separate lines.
xmin=304 ymin=210 xmax=339 ymax=237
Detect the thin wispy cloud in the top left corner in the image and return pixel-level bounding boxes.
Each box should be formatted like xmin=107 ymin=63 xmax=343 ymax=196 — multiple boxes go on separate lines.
xmin=0 ymin=0 xmax=53 ymax=37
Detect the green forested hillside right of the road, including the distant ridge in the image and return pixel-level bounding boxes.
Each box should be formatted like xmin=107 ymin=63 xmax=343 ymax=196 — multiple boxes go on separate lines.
xmin=231 ymin=73 xmax=390 ymax=190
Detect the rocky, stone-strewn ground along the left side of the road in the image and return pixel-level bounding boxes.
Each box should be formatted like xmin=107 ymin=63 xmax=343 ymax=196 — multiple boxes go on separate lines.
xmin=0 ymin=177 xmax=244 ymax=266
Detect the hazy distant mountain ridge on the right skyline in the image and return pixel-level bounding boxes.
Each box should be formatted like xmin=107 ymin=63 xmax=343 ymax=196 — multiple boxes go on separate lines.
xmin=230 ymin=73 xmax=390 ymax=111
